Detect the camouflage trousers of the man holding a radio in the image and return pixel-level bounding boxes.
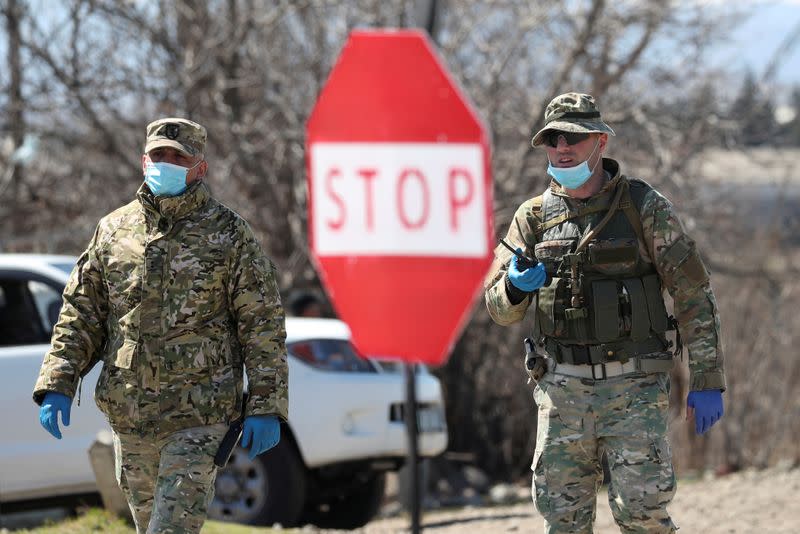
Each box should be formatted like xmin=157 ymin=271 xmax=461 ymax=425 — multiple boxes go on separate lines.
xmin=531 ymin=372 xmax=676 ymax=534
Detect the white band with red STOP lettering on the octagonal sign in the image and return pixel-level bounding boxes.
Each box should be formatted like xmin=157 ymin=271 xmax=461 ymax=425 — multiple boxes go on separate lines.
xmin=311 ymin=143 xmax=487 ymax=258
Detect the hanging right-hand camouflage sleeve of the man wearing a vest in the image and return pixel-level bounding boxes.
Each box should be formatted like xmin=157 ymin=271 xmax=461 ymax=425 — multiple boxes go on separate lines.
xmin=642 ymin=190 xmax=725 ymax=391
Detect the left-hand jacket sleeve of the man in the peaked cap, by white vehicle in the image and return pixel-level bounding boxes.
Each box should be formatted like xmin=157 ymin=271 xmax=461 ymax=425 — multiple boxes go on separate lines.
xmin=33 ymin=225 xmax=108 ymax=405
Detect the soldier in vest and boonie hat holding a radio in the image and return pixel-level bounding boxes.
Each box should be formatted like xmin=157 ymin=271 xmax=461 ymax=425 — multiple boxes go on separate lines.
xmin=485 ymin=93 xmax=725 ymax=533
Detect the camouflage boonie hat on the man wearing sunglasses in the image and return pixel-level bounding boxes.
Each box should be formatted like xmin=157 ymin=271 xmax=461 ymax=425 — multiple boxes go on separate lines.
xmin=531 ymin=93 xmax=616 ymax=147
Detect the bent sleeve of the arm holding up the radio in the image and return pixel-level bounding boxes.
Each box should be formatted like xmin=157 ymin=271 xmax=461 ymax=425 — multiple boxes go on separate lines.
xmin=483 ymin=202 xmax=534 ymax=326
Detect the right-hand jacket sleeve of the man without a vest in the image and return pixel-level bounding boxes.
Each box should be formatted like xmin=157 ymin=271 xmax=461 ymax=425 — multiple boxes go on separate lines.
xmin=229 ymin=222 xmax=289 ymax=420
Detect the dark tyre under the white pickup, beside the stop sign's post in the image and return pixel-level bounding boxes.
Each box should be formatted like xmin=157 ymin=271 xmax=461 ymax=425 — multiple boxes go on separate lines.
xmin=308 ymin=473 xmax=386 ymax=530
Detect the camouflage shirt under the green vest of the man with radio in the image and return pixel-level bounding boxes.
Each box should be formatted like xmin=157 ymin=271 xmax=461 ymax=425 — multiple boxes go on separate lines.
xmin=484 ymin=158 xmax=725 ymax=390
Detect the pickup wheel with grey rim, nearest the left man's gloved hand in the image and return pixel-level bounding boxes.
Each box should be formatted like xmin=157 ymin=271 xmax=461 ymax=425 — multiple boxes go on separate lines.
xmin=208 ymin=439 xmax=306 ymax=527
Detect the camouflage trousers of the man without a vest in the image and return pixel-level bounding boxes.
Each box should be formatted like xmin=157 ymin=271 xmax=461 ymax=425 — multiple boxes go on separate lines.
xmin=114 ymin=424 xmax=228 ymax=534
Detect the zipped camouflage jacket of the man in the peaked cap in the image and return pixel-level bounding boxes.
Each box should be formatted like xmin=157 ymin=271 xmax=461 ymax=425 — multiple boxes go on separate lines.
xmin=33 ymin=183 xmax=288 ymax=434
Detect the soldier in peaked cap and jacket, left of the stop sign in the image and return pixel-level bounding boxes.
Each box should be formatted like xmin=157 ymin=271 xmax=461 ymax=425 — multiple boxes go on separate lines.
xmin=33 ymin=118 xmax=288 ymax=533
